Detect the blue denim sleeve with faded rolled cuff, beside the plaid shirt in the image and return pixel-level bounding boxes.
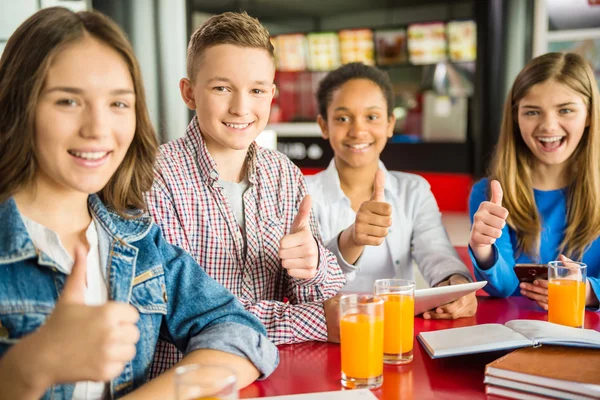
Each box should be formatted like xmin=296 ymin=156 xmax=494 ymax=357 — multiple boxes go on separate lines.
xmin=155 ymin=229 xmax=279 ymax=378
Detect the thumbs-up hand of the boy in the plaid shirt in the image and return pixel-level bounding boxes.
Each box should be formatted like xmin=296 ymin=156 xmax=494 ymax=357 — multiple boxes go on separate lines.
xmin=279 ymin=195 xmax=319 ymax=279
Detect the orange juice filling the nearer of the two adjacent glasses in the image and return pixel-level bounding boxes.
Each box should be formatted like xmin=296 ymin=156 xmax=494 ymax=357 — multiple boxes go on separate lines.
xmin=340 ymin=314 xmax=383 ymax=379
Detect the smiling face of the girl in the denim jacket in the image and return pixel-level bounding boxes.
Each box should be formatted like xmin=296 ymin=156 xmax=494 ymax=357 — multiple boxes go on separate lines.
xmin=34 ymin=35 xmax=136 ymax=195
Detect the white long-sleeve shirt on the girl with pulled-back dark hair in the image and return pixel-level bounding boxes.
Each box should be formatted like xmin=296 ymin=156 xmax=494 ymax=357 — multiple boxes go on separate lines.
xmin=306 ymin=160 xmax=472 ymax=291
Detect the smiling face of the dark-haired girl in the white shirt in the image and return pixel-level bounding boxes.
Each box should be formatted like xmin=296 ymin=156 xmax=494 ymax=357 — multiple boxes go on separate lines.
xmin=318 ymin=79 xmax=396 ymax=168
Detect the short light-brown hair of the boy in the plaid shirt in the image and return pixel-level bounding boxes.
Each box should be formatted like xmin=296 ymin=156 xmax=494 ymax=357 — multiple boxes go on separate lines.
xmin=187 ymin=11 xmax=275 ymax=80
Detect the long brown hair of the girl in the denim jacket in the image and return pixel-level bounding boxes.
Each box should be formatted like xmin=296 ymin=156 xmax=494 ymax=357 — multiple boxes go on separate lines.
xmin=0 ymin=7 xmax=158 ymax=217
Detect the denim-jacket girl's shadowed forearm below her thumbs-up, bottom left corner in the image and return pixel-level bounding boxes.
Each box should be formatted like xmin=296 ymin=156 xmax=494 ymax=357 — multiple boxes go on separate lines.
xmin=0 ymin=337 xmax=51 ymax=400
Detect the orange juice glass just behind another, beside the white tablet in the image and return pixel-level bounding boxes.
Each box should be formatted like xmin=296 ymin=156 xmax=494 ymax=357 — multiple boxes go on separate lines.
xmin=375 ymin=279 xmax=415 ymax=364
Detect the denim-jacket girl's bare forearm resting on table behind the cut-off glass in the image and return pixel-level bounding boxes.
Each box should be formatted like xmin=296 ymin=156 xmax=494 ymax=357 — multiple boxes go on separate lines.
xmin=123 ymin=349 xmax=259 ymax=400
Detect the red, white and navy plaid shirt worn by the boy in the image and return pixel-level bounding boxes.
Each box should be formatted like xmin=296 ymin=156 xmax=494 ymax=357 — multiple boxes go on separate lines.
xmin=146 ymin=117 xmax=345 ymax=375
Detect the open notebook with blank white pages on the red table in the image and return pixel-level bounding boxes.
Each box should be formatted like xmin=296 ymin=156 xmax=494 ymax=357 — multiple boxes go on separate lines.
xmin=417 ymin=319 xmax=600 ymax=358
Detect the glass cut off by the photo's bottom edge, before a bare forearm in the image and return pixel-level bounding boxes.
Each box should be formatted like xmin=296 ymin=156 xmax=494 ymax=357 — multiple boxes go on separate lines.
xmin=175 ymin=364 xmax=238 ymax=400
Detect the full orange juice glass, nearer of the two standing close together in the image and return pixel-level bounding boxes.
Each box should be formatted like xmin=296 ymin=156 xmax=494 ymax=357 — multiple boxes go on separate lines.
xmin=340 ymin=294 xmax=383 ymax=389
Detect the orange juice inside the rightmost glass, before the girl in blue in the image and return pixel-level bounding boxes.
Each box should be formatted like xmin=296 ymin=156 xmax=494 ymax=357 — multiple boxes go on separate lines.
xmin=548 ymin=279 xmax=585 ymax=328
